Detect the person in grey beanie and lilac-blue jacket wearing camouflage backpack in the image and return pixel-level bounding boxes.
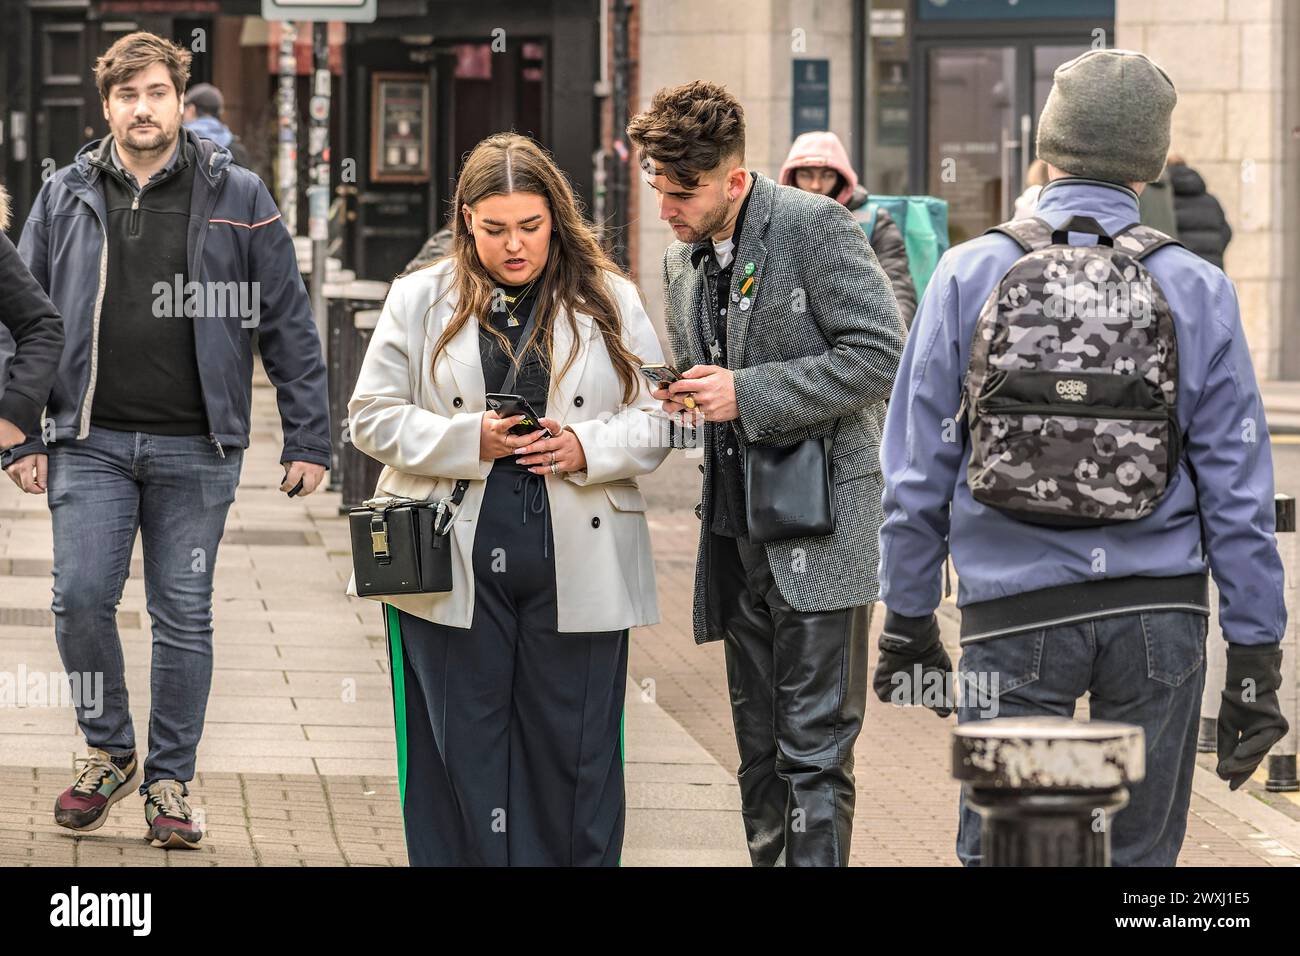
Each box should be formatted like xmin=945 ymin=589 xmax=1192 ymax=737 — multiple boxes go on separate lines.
xmin=872 ymin=49 xmax=1287 ymax=866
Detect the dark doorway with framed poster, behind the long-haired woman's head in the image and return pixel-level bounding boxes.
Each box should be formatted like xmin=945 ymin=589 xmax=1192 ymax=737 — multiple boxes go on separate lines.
xmin=335 ymin=0 xmax=599 ymax=280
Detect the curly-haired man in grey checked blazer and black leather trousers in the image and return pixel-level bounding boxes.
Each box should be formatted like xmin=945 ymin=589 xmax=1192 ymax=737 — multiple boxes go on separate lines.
xmin=628 ymin=82 xmax=904 ymax=866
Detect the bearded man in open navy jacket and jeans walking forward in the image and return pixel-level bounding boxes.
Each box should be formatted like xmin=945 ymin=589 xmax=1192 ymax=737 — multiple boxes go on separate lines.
xmin=4 ymin=33 xmax=330 ymax=847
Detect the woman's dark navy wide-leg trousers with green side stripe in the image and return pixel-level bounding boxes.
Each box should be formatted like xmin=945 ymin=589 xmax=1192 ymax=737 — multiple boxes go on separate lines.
xmin=385 ymin=462 xmax=628 ymax=866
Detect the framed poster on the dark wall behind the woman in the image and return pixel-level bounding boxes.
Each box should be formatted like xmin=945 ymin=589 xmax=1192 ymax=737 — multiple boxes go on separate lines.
xmin=371 ymin=73 xmax=429 ymax=182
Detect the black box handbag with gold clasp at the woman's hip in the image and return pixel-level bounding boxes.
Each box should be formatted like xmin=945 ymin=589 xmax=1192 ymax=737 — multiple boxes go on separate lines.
xmin=347 ymin=479 xmax=469 ymax=597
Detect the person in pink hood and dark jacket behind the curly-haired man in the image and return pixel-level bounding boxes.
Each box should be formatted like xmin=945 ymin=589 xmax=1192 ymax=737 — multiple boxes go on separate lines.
xmin=777 ymin=130 xmax=917 ymax=329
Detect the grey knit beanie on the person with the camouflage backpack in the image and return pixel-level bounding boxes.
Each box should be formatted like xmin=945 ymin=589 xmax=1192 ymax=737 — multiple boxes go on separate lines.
xmin=1037 ymin=49 xmax=1178 ymax=183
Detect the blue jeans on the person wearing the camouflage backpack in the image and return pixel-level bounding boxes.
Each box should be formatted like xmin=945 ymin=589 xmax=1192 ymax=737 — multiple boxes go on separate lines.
xmin=957 ymin=611 xmax=1206 ymax=866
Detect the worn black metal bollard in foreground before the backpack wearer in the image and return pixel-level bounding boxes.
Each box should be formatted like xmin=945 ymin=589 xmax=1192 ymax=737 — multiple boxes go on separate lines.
xmin=953 ymin=717 xmax=1147 ymax=866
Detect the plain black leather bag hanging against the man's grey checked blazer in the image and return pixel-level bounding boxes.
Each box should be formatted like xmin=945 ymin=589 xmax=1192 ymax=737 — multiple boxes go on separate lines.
xmin=745 ymin=421 xmax=840 ymax=544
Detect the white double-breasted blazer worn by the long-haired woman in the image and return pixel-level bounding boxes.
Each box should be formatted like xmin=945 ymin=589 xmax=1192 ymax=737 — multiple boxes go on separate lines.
xmin=347 ymin=260 xmax=670 ymax=632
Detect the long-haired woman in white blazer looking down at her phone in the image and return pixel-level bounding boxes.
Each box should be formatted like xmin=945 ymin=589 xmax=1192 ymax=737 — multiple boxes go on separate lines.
xmin=348 ymin=134 xmax=668 ymax=865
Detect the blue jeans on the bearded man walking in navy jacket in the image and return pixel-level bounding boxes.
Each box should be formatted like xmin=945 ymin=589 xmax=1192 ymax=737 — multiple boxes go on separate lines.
xmin=48 ymin=427 xmax=243 ymax=793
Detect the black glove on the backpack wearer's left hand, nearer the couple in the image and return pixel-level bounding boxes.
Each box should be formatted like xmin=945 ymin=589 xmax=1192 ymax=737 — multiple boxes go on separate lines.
xmin=871 ymin=611 xmax=953 ymax=717
